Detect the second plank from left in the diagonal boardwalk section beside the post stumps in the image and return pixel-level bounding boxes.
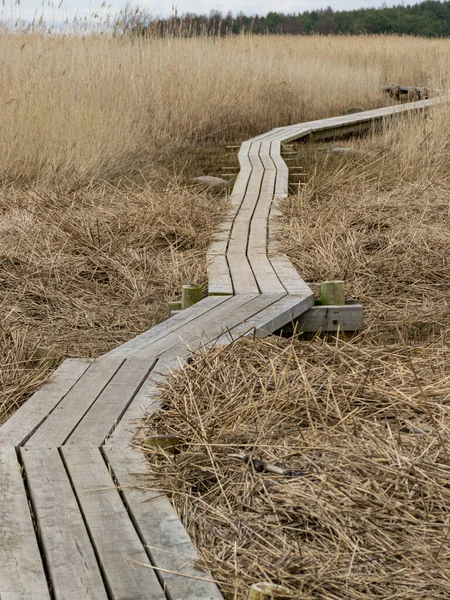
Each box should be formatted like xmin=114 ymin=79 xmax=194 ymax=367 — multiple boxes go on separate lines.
xmin=130 ymin=294 xmax=258 ymax=357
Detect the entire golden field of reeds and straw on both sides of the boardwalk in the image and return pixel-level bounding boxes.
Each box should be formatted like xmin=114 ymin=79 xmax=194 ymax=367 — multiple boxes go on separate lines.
xmin=0 ymin=33 xmax=450 ymax=600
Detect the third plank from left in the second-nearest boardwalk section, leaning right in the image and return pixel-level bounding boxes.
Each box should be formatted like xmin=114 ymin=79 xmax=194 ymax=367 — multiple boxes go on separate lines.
xmin=66 ymin=357 xmax=156 ymax=448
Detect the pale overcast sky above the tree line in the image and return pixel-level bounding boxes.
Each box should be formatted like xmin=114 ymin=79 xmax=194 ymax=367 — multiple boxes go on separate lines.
xmin=0 ymin=0 xmax=409 ymax=20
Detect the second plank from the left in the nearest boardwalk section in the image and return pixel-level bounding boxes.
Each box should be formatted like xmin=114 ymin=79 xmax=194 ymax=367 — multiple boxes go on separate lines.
xmin=21 ymin=448 xmax=108 ymax=600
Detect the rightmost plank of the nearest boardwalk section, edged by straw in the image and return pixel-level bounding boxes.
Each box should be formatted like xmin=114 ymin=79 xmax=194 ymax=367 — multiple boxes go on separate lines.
xmin=105 ymin=448 xmax=222 ymax=600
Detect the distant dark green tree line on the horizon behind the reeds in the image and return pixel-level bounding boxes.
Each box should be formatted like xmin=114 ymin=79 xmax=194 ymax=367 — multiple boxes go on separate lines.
xmin=131 ymin=0 xmax=450 ymax=37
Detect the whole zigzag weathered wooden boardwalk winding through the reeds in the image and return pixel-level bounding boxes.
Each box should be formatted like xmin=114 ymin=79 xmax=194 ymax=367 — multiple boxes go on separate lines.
xmin=0 ymin=91 xmax=448 ymax=600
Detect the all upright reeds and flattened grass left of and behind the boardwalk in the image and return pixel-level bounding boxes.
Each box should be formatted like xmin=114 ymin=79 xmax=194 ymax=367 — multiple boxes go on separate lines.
xmin=4 ymin=27 xmax=442 ymax=420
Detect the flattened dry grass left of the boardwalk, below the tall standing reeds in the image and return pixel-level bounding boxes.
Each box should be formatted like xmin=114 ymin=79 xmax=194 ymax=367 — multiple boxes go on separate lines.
xmin=0 ymin=185 xmax=226 ymax=421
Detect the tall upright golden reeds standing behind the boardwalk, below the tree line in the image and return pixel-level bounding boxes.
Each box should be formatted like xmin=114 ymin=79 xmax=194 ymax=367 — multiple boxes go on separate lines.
xmin=0 ymin=34 xmax=450 ymax=189
